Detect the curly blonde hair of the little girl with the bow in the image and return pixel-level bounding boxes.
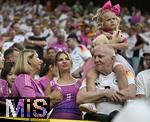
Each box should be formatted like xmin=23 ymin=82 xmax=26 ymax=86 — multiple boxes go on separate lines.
xmin=92 ymin=8 xmax=120 ymax=31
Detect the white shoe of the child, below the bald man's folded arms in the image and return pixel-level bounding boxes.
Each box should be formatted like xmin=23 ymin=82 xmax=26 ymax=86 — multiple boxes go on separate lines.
xmin=79 ymin=103 xmax=97 ymax=113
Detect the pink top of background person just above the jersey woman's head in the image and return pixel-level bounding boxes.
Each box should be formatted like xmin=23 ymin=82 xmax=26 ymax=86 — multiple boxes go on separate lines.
xmin=51 ymin=42 xmax=69 ymax=52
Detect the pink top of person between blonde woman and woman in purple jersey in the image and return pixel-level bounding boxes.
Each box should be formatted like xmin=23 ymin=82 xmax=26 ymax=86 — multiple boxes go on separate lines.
xmin=39 ymin=76 xmax=50 ymax=92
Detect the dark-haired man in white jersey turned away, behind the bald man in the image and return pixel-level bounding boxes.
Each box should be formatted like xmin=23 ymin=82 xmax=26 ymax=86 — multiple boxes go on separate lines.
xmin=67 ymin=34 xmax=92 ymax=77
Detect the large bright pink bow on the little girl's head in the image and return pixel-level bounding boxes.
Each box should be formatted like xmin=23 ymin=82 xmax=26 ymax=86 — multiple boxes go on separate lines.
xmin=102 ymin=0 xmax=120 ymax=16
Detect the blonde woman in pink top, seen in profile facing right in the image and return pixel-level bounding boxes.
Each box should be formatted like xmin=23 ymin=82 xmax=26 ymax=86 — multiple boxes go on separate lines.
xmin=12 ymin=49 xmax=61 ymax=115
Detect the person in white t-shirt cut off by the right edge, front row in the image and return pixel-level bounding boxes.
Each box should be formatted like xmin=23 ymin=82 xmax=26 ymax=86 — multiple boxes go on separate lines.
xmin=136 ymin=52 xmax=150 ymax=102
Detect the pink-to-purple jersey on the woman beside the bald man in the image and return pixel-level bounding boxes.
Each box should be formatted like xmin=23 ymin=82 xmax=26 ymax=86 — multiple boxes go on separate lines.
xmin=50 ymin=80 xmax=82 ymax=119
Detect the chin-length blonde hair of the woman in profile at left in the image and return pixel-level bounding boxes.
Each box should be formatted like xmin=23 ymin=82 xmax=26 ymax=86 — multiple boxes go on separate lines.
xmin=14 ymin=49 xmax=36 ymax=75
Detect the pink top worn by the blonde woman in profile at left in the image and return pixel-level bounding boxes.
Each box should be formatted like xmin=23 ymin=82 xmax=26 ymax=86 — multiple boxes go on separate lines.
xmin=12 ymin=74 xmax=44 ymax=106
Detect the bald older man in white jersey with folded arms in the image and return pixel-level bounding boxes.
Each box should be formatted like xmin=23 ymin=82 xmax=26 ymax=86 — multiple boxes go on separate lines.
xmin=77 ymin=45 xmax=136 ymax=121
